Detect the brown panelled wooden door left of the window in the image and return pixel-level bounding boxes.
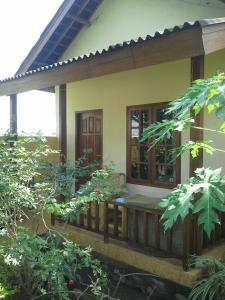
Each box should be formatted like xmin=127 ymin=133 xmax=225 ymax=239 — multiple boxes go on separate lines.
xmin=76 ymin=110 xmax=102 ymax=165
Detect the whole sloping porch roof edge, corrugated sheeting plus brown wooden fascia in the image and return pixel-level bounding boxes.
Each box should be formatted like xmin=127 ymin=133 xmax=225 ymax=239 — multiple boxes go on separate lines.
xmin=0 ymin=18 xmax=225 ymax=96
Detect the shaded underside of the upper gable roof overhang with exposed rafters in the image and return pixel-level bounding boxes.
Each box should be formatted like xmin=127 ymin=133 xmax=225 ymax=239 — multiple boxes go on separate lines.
xmin=16 ymin=0 xmax=102 ymax=74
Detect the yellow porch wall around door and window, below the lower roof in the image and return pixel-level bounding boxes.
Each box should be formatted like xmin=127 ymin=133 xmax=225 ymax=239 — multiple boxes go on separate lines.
xmin=63 ymin=59 xmax=190 ymax=197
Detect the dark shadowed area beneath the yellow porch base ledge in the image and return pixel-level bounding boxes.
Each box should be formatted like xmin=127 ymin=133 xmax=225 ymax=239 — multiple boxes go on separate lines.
xmin=95 ymin=254 xmax=190 ymax=300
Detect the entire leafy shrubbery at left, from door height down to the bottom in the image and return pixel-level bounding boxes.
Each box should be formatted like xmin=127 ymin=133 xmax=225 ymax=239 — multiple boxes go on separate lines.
xmin=0 ymin=135 xmax=113 ymax=299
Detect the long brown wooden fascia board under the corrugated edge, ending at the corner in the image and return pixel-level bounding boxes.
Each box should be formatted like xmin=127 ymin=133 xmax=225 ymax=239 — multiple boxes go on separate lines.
xmin=0 ymin=25 xmax=205 ymax=96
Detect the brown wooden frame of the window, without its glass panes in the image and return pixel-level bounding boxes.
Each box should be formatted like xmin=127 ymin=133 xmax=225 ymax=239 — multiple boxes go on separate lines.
xmin=126 ymin=102 xmax=181 ymax=189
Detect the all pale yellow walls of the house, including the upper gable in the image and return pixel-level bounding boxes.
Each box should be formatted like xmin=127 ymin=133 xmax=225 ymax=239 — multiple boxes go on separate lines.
xmin=53 ymin=0 xmax=225 ymax=197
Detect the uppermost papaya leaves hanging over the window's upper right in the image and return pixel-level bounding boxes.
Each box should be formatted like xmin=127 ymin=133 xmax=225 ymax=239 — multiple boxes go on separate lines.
xmin=142 ymin=73 xmax=225 ymax=150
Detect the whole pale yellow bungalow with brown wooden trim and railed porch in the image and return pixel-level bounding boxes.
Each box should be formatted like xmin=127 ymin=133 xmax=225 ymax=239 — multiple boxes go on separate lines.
xmin=0 ymin=0 xmax=225 ymax=286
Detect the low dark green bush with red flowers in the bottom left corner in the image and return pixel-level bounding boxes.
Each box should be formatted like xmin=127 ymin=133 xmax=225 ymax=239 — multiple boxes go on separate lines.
xmin=2 ymin=230 xmax=107 ymax=300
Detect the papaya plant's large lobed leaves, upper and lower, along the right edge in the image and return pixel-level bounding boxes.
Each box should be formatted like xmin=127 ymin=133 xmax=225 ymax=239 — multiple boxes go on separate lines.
xmin=142 ymin=73 xmax=225 ymax=237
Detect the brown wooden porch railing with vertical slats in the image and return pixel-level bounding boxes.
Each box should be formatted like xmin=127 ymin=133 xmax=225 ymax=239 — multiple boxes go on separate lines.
xmin=54 ymin=201 xmax=225 ymax=270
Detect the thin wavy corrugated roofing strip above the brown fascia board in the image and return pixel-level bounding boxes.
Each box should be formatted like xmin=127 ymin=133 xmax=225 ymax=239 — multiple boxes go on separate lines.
xmin=0 ymin=18 xmax=225 ymax=83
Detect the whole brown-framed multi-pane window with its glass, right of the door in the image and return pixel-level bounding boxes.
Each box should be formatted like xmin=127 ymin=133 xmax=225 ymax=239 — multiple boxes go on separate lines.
xmin=127 ymin=104 xmax=180 ymax=188
